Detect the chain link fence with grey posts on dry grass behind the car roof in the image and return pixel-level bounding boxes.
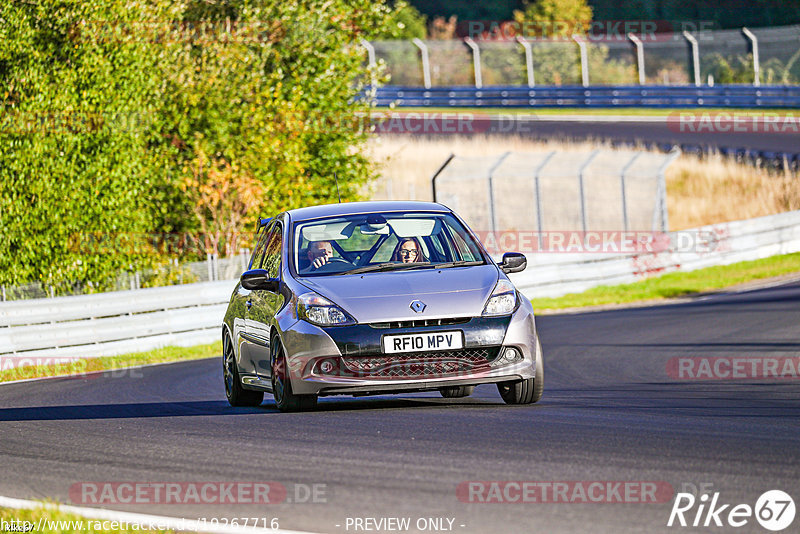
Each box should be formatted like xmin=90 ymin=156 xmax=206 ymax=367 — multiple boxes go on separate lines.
xmin=373 ymin=149 xmax=680 ymax=239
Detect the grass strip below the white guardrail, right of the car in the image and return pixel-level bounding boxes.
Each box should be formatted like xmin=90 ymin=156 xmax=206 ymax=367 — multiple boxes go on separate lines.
xmin=531 ymin=253 xmax=800 ymax=311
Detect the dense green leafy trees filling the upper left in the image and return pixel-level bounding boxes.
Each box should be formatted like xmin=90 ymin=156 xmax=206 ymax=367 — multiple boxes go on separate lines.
xmin=0 ymin=0 xmax=400 ymax=292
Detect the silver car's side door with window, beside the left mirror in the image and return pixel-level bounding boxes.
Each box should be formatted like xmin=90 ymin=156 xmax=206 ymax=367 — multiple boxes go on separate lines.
xmin=245 ymin=221 xmax=284 ymax=377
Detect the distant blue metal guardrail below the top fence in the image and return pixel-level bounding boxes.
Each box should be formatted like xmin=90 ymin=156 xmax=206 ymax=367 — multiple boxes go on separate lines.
xmin=374 ymin=85 xmax=800 ymax=108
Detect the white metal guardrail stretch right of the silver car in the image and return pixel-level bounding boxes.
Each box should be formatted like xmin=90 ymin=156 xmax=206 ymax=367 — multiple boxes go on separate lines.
xmin=511 ymin=211 xmax=800 ymax=298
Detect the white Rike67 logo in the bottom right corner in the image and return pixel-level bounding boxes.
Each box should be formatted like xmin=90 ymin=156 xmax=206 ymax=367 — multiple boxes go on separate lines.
xmin=667 ymin=490 xmax=795 ymax=532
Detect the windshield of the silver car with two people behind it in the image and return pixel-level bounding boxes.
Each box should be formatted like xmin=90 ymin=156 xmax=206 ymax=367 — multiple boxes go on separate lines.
xmin=293 ymin=213 xmax=486 ymax=276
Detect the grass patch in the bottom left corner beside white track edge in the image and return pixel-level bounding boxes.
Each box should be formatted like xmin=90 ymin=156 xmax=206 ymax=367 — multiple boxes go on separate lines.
xmin=0 ymin=508 xmax=172 ymax=534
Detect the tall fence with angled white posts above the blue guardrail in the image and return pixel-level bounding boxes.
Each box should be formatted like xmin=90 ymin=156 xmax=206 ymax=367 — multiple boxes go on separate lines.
xmin=372 ymin=25 xmax=800 ymax=87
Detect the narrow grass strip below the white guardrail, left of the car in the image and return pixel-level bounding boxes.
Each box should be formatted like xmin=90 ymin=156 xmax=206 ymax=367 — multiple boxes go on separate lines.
xmin=0 ymin=341 xmax=222 ymax=382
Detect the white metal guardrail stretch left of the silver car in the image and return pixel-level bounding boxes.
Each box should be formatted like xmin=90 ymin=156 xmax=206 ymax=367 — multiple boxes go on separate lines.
xmin=0 ymin=280 xmax=234 ymax=359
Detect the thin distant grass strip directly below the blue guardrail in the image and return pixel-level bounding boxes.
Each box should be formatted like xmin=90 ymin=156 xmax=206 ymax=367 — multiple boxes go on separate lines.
xmin=375 ymin=107 xmax=798 ymax=117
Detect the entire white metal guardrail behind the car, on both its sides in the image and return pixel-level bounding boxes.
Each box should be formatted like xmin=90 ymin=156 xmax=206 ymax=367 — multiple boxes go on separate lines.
xmin=0 ymin=211 xmax=800 ymax=362
